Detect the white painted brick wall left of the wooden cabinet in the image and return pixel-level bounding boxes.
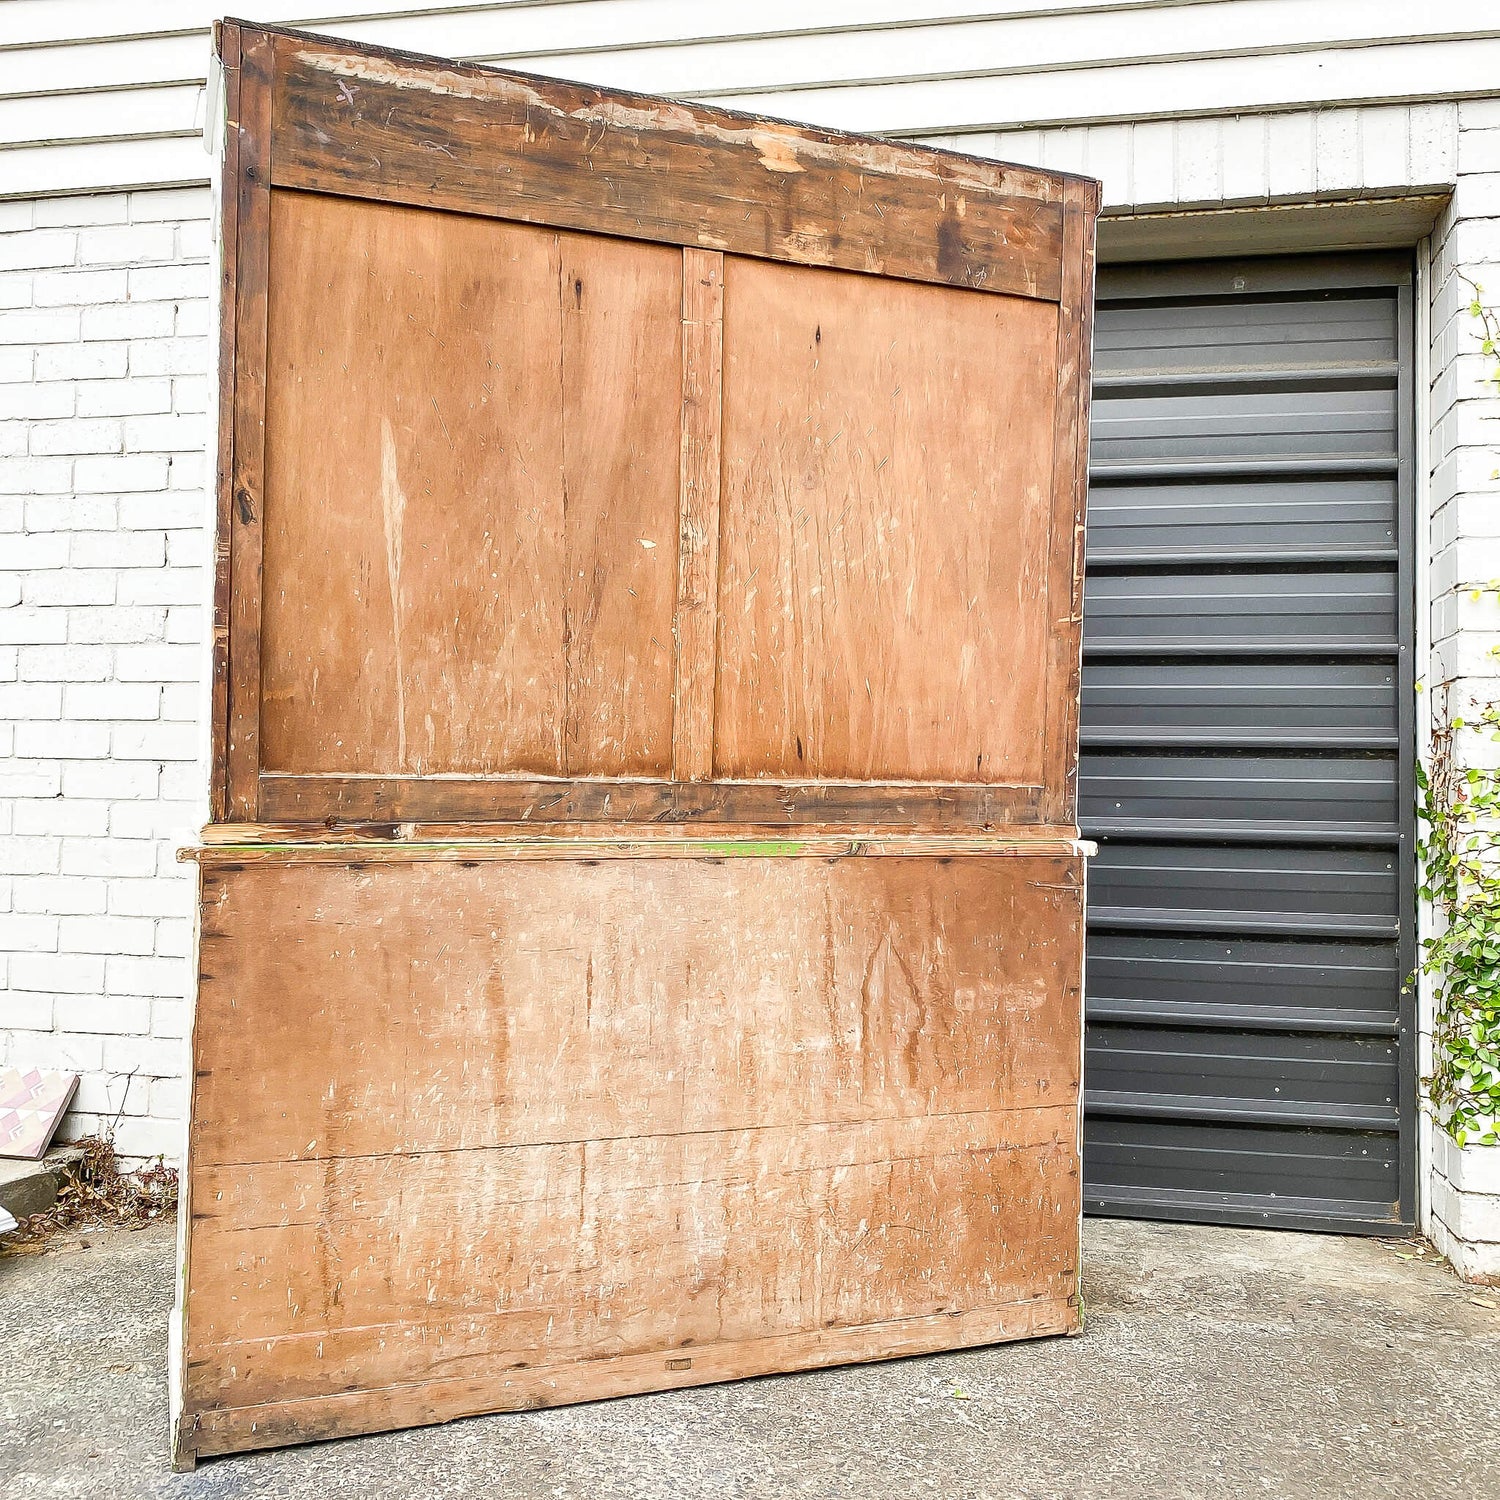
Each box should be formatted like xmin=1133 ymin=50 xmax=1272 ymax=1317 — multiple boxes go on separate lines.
xmin=0 ymin=189 xmax=212 ymax=1158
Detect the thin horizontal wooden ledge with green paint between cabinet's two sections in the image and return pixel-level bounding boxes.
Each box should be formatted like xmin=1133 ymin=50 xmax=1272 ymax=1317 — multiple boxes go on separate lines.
xmin=187 ymin=824 xmax=1095 ymax=864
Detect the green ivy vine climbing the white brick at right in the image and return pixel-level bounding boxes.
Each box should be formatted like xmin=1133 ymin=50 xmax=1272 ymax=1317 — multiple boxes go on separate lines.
xmin=1416 ymin=278 xmax=1500 ymax=1146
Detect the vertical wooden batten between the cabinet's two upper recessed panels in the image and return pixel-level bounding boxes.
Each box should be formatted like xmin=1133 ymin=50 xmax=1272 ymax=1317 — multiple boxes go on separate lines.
xmin=672 ymin=248 xmax=725 ymax=782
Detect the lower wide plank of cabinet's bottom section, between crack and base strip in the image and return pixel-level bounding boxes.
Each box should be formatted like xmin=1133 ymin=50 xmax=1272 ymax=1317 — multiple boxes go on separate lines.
xmin=185 ymin=1128 xmax=1079 ymax=1409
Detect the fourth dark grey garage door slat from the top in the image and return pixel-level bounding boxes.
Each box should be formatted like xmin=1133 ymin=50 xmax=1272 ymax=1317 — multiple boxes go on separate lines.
xmin=1083 ymin=569 xmax=1397 ymax=654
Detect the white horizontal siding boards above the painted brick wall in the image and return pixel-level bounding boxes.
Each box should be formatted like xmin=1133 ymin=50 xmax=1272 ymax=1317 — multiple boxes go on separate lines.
xmin=0 ymin=0 xmax=1500 ymax=197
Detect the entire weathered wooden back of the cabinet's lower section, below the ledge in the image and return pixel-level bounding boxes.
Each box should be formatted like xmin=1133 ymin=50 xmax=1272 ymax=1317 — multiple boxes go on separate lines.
xmin=179 ymin=851 xmax=1082 ymax=1454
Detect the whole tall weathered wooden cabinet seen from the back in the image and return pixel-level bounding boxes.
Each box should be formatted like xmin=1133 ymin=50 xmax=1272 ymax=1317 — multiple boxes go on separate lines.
xmin=174 ymin=14 xmax=1097 ymax=1464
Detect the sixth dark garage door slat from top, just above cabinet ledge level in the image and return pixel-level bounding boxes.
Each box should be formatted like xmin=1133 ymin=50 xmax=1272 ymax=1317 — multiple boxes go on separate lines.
xmin=1079 ymin=752 xmax=1398 ymax=834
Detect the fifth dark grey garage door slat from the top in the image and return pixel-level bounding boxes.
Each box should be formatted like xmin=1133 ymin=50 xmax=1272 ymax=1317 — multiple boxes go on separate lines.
xmin=1082 ymin=659 xmax=1397 ymax=747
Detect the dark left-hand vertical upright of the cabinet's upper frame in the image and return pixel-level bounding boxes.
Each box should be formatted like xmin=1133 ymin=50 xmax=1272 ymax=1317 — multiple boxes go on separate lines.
xmin=228 ymin=32 xmax=273 ymax=818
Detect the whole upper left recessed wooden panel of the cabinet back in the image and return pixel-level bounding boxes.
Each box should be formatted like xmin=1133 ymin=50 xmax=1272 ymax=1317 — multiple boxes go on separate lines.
xmin=263 ymin=192 xmax=681 ymax=776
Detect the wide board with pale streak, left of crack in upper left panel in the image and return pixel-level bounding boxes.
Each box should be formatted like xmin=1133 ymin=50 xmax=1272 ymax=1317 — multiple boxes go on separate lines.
xmin=264 ymin=192 xmax=566 ymax=774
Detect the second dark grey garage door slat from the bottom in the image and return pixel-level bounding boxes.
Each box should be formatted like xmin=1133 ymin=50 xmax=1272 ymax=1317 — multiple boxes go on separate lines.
xmin=1086 ymin=1025 xmax=1398 ymax=1130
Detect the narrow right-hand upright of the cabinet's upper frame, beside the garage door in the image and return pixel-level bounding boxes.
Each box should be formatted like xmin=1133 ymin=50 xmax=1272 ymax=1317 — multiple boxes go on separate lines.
xmin=1043 ymin=183 xmax=1100 ymax=822
